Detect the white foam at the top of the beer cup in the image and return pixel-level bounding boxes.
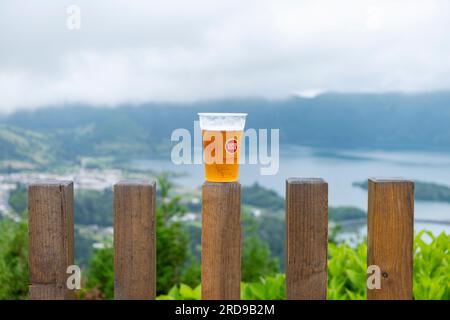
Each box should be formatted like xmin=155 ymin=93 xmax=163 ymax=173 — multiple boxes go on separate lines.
xmin=198 ymin=113 xmax=247 ymax=131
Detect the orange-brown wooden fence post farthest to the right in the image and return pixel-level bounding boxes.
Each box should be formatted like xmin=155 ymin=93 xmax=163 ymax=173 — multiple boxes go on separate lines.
xmin=367 ymin=178 xmax=414 ymax=300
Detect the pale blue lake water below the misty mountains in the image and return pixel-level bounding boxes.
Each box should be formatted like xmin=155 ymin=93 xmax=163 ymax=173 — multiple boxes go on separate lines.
xmin=133 ymin=147 xmax=450 ymax=233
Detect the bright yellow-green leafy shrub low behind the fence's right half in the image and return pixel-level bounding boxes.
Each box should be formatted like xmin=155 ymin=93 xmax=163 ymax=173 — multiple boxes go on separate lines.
xmin=158 ymin=231 xmax=450 ymax=300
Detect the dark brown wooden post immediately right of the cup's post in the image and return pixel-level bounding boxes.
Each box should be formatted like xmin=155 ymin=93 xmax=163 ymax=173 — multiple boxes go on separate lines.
xmin=286 ymin=178 xmax=328 ymax=300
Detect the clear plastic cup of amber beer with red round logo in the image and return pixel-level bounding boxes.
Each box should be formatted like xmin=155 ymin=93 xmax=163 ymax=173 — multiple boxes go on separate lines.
xmin=198 ymin=113 xmax=247 ymax=182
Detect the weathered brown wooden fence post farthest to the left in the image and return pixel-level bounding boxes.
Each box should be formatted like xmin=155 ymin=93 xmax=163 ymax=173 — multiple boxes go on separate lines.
xmin=28 ymin=181 xmax=74 ymax=300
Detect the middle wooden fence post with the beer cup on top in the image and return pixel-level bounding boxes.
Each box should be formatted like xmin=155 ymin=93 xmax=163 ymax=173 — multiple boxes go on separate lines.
xmin=202 ymin=182 xmax=241 ymax=300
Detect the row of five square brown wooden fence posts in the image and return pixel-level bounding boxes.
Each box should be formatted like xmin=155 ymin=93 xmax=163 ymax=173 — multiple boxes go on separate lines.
xmin=28 ymin=179 xmax=414 ymax=300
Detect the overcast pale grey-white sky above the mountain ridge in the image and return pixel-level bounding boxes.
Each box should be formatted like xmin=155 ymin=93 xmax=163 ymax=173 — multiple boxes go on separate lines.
xmin=0 ymin=0 xmax=450 ymax=112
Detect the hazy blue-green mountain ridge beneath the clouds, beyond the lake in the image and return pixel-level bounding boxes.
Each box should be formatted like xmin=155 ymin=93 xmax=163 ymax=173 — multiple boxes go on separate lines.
xmin=0 ymin=92 xmax=450 ymax=171
